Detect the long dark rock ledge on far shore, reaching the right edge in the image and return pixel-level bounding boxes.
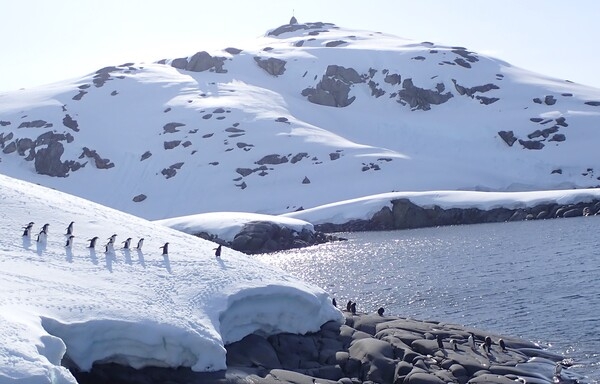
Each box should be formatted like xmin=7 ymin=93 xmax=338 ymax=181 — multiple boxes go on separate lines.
xmin=315 ymin=196 xmax=600 ymax=233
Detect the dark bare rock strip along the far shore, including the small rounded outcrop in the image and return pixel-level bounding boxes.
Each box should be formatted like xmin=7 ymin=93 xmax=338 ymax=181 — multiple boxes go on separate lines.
xmin=194 ymin=199 xmax=600 ymax=255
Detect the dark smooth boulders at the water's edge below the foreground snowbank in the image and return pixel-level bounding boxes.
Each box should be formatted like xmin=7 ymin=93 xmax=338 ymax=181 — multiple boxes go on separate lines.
xmin=72 ymin=311 xmax=585 ymax=384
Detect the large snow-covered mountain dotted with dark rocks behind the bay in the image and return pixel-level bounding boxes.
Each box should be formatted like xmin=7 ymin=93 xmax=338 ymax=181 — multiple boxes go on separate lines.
xmin=0 ymin=23 xmax=600 ymax=219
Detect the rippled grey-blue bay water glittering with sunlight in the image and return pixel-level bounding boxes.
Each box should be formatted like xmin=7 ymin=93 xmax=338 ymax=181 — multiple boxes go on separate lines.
xmin=257 ymin=217 xmax=600 ymax=382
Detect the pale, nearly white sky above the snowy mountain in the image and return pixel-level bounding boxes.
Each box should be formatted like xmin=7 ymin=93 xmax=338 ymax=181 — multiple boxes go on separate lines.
xmin=0 ymin=0 xmax=600 ymax=92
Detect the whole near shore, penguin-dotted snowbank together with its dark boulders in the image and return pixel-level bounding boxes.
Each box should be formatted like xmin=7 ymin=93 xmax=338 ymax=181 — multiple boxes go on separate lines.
xmin=0 ymin=175 xmax=578 ymax=384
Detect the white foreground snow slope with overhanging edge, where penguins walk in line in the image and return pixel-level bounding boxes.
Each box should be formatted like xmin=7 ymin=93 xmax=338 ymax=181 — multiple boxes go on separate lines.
xmin=0 ymin=175 xmax=341 ymax=383
